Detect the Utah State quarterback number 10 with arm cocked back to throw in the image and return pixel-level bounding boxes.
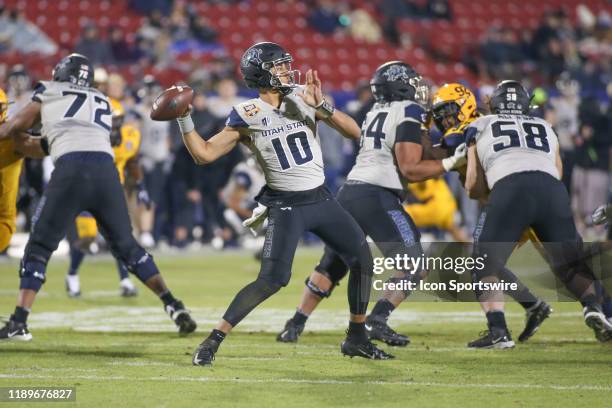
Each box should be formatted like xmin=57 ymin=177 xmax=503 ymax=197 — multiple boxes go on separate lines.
xmin=178 ymin=42 xmax=392 ymax=365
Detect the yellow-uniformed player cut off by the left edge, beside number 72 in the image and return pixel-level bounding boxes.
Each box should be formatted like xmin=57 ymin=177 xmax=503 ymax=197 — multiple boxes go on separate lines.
xmin=0 ymin=89 xmax=23 ymax=253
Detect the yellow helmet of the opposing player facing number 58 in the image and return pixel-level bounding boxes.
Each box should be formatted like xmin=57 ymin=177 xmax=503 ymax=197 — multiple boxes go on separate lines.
xmin=431 ymin=83 xmax=476 ymax=133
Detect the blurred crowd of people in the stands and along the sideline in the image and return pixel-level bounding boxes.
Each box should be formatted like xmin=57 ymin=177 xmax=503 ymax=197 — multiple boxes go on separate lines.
xmin=0 ymin=0 xmax=612 ymax=252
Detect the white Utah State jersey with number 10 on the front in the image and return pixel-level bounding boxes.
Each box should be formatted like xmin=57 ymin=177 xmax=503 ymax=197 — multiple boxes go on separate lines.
xmin=226 ymin=90 xmax=325 ymax=191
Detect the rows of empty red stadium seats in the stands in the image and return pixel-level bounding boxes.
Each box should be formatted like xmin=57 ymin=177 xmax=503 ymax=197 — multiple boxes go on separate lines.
xmin=3 ymin=0 xmax=606 ymax=90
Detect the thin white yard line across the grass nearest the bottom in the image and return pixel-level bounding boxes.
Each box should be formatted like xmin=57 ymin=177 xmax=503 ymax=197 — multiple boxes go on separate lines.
xmin=0 ymin=368 xmax=612 ymax=392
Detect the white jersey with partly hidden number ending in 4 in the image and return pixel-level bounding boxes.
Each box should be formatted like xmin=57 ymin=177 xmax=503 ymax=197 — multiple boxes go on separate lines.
xmin=347 ymin=101 xmax=425 ymax=190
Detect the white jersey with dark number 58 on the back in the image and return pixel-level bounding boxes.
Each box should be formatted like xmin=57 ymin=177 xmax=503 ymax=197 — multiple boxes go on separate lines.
xmin=465 ymin=115 xmax=561 ymax=189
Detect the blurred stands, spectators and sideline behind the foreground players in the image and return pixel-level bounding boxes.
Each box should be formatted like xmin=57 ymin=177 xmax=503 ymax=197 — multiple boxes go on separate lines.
xmin=0 ymin=0 xmax=612 ymax=255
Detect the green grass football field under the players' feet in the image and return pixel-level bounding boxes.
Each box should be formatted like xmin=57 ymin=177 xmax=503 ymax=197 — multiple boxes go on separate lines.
xmin=0 ymin=249 xmax=612 ymax=408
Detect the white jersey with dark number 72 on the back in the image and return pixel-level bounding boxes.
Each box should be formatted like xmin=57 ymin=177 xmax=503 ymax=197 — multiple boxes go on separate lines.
xmin=32 ymin=81 xmax=114 ymax=161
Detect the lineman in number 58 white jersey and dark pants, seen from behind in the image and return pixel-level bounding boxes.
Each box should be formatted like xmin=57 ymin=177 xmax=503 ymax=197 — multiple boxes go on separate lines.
xmin=465 ymin=81 xmax=612 ymax=348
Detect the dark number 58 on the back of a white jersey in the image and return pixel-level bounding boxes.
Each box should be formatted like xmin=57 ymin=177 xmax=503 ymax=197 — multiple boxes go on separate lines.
xmin=491 ymin=121 xmax=550 ymax=153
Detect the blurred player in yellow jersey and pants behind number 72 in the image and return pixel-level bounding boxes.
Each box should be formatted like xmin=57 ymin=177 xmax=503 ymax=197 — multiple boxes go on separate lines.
xmin=66 ymin=98 xmax=151 ymax=297
